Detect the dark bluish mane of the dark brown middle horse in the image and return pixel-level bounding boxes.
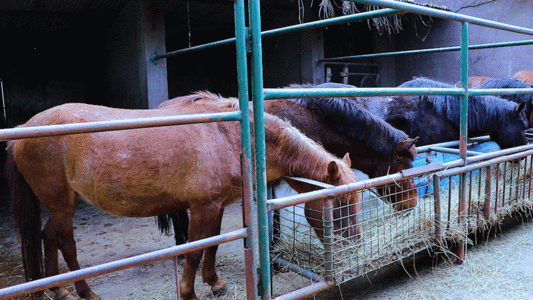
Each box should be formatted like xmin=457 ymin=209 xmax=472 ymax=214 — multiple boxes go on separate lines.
xmin=289 ymin=84 xmax=409 ymax=157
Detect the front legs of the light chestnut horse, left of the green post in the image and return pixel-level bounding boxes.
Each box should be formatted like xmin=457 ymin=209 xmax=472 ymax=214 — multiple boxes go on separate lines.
xmin=180 ymin=203 xmax=222 ymax=300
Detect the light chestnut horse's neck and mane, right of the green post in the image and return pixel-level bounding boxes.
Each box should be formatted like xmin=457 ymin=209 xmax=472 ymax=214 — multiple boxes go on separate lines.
xmin=265 ymin=113 xmax=352 ymax=181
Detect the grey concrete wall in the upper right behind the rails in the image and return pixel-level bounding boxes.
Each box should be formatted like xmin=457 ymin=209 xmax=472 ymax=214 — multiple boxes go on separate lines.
xmin=386 ymin=0 xmax=533 ymax=86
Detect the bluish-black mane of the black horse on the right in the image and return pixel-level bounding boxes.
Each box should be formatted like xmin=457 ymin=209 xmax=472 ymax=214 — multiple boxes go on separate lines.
xmin=391 ymin=77 xmax=516 ymax=131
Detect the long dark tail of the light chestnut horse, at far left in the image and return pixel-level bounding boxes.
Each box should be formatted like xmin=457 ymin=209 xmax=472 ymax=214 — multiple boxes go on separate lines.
xmin=5 ymin=141 xmax=43 ymax=281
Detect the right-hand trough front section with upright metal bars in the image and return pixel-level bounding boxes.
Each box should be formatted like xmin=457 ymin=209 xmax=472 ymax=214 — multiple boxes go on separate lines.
xmin=440 ymin=156 xmax=533 ymax=237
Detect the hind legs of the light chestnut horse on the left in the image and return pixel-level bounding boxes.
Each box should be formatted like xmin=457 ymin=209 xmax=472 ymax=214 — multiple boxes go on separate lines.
xmin=42 ymin=213 xmax=100 ymax=300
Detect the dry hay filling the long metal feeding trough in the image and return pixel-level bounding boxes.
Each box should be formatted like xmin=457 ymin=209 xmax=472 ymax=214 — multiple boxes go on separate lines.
xmin=272 ymin=159 xmax=533 ymax=283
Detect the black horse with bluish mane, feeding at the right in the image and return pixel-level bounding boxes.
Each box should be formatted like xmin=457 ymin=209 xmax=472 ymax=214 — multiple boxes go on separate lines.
xmin=385 ymin=78 xmax=529 ymax=149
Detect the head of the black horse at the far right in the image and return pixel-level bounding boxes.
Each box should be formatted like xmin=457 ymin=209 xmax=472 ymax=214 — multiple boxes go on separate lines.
xmin=490 ymin=101 xmax=529 ymax=149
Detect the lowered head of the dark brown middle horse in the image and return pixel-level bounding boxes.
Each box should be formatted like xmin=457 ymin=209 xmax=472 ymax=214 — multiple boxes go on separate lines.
xmin=378 ymin=137 xmax=419 ymax=211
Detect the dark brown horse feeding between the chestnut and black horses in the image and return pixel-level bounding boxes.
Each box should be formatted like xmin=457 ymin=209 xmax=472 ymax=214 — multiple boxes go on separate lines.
xmin=265 ymin=84 xmax=417 ymax=210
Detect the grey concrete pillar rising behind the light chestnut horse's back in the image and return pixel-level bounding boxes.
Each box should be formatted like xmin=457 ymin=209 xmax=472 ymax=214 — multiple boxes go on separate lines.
xmin=103 ymin=0 xmax=168 ymax=108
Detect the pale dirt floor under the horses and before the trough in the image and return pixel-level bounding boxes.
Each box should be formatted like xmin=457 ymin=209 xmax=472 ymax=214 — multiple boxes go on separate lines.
xmin=0 ymin=197 xmax=533 ymax=300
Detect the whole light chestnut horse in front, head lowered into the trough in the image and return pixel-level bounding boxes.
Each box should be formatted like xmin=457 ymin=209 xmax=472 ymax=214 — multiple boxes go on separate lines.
xmin=6 ymin=92 xmax=361 ymax=299
